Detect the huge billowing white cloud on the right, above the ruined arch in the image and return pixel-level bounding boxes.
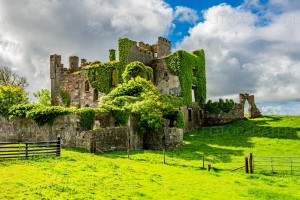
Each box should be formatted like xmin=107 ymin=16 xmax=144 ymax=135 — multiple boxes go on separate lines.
xmin=176 ymin=3 xmax=300 ymax=102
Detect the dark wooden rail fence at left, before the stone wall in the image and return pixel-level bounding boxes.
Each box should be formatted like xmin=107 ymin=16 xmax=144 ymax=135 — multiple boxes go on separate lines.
xmin=0 ymin=137 xmax=61 ymax=159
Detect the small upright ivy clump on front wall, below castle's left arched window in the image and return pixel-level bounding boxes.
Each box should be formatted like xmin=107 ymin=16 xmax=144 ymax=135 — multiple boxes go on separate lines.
xmin=79 ymin=108 xmax=96 ymax=131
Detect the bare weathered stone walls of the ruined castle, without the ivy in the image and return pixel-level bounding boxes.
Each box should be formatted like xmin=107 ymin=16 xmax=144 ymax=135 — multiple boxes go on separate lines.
xmin=50 ymin=37 xmax=205 ymax=130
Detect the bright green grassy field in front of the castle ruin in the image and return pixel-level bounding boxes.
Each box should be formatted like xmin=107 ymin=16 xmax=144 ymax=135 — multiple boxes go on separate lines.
xmin=0 ymin=116 xmax=300 ymax=200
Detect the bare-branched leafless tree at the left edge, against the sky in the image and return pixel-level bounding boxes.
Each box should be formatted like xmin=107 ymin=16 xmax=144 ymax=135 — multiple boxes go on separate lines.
xmin=0 ymin=66 xmax=28 ymax=87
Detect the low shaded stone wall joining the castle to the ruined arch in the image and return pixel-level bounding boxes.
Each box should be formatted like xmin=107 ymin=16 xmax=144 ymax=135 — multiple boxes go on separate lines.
xmin=204 ymin=104 xmax=245 ymax=126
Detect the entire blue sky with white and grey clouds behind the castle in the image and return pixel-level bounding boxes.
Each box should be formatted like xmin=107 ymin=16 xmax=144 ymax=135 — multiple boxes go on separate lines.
xmin=0 ymin=0 xmax=300 ymax=115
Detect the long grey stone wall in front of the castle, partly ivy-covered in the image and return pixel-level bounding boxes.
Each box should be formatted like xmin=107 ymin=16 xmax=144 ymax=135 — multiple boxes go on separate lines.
xmin=0 ymin=113 xmax=183 ymax=153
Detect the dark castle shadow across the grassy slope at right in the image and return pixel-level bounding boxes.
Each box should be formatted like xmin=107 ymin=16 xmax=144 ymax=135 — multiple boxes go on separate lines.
xmin=168 ymin=116 xmax=300 ymax=163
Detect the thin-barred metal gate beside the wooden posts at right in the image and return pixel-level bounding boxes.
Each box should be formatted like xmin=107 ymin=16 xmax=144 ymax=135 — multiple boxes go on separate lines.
xmin=250 ymin=154 xmax=300 ymax=174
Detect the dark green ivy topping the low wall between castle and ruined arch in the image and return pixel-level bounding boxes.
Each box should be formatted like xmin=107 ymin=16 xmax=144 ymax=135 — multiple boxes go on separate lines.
xmin=204 ymin=99 xmax=235 ymax=114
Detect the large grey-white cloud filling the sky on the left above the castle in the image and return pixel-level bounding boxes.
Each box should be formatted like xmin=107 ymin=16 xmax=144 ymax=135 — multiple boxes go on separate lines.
xmin=0 ymin=0 xmax=173 ymax=98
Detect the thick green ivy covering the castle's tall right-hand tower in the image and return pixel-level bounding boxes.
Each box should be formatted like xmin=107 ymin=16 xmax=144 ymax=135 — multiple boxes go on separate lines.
xmin=163 ymin=50 xmax=206 ymax=107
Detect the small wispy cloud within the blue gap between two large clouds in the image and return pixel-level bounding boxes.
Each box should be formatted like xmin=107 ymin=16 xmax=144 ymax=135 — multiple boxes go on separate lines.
xmin=174 ymin=6 xmax=199 ymax=24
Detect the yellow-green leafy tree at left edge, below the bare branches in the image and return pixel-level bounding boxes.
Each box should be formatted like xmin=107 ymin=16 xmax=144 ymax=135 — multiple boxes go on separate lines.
xmin=0 ymin=86 xmax=28 ymax=118
